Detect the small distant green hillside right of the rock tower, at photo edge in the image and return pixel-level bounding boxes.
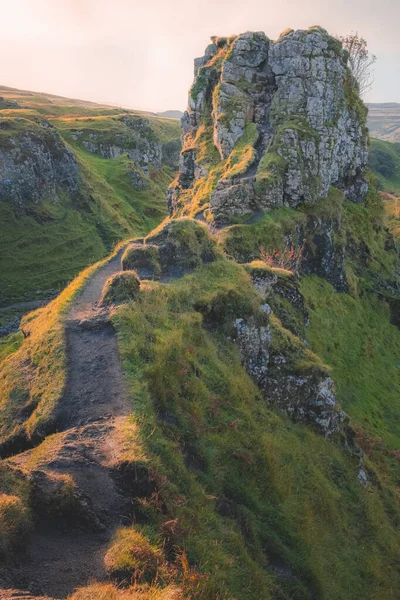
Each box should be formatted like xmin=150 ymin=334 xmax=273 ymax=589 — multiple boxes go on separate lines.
xmin=369 ymin=139 xmax=400 ymax=195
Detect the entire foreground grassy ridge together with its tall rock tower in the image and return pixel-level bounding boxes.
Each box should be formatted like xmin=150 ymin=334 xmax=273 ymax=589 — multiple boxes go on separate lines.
xmin=0 ymin=27 xmax=400 ymax=600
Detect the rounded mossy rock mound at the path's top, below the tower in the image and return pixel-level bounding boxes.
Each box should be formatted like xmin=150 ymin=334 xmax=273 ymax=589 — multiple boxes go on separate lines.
xmin=146 ymin=219 xmax=217 ymax=274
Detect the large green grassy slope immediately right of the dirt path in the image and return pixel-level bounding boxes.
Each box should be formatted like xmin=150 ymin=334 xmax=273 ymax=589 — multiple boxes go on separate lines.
xmin=111 ymin=259 xmax=400 ymax=600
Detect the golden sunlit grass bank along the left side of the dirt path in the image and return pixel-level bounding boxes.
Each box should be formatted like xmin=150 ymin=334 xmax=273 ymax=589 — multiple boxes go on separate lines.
xmin=0 ymin=243 xmax=130 ymax=440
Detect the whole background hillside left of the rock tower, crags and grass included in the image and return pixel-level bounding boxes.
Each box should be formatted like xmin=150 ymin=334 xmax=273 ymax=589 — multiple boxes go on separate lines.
xmin=0 ymin=88 xmax=180 ymax=305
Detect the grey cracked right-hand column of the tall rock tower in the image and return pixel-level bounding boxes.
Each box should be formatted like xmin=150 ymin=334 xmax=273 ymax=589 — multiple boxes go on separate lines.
xmin=269 ymin=30 xmax=368 ymax=206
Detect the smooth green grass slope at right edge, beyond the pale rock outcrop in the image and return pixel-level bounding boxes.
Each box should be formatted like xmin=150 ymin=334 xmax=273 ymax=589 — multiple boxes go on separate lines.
xmin=301 ymin=277 xmax=400 ymax=449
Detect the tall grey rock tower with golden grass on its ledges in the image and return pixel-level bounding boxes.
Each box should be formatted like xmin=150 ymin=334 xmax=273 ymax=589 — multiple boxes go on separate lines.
xmin=170 ymin=28 xmax=368 ymax=222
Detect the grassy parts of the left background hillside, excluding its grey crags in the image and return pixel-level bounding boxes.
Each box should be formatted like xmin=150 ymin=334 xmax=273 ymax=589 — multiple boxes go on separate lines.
xmin=0 ymin=88 xmax=180 ymax=305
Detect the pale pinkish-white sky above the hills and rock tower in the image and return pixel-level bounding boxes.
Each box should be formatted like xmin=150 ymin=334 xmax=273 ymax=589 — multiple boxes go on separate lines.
xmin=0 ymin=0 xmax=400 ymax=111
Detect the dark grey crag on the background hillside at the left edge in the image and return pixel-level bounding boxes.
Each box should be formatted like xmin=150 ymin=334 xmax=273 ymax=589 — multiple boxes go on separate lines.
xmin=0 ymin=121 xmax=79 ymax=208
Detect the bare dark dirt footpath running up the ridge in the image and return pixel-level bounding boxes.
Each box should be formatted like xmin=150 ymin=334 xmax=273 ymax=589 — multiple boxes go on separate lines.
xmin=0 ymin=246 xmax=141 ymax=599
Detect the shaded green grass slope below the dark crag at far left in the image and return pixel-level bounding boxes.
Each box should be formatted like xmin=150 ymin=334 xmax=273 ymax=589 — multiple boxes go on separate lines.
xmin=0 ymin=202 xmax=107 ymax=304
